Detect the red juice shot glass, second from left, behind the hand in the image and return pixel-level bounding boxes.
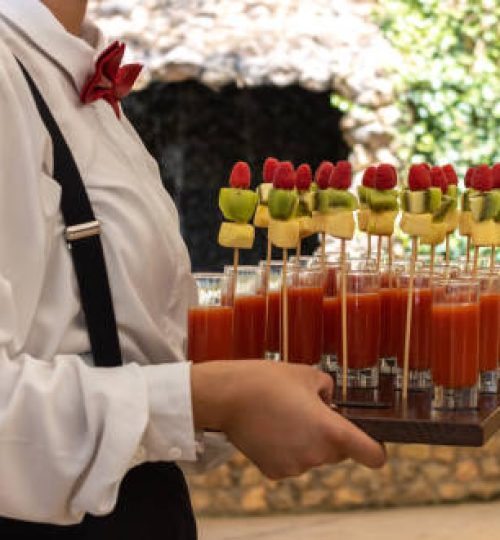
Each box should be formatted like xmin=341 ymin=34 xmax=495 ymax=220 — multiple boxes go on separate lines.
xmin=224 ymin=266 xmax=266 ymax=360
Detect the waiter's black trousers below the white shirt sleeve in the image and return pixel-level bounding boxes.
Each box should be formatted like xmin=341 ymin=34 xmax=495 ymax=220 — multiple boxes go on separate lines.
xmin=0 ymin=463 xmax=197 ymax=540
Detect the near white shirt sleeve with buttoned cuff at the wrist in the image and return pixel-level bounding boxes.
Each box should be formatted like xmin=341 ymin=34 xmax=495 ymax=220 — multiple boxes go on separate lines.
xmin=0 ymin=45 xmax=196 ymax=524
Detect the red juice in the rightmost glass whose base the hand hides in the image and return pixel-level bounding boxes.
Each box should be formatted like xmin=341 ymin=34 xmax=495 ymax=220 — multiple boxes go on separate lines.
xmin=288 ymin=287 xmax=323 ymax=365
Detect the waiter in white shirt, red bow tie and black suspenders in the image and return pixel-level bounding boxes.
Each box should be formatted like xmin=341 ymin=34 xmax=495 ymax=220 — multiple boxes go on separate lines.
xmin=0 ymin=0 xmax=385 ymax=540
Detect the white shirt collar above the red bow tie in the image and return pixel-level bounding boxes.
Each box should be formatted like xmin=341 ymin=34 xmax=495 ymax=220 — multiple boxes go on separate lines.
xmin=0 ymin=0 xmax=104 ymax=92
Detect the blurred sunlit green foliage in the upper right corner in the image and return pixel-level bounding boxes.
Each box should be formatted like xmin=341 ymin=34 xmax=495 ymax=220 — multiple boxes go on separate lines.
xmin=374 ymin=0 xmax=500 ymax=175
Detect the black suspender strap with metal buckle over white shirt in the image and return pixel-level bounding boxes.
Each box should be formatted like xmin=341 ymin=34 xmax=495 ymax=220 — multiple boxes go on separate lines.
xmin=18 ymin=60 xmax=122 ymax=367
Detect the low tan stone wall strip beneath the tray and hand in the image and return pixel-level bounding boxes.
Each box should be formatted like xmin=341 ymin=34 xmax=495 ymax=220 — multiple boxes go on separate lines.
xmin=189 ymin=435 xmax=500 ymax=515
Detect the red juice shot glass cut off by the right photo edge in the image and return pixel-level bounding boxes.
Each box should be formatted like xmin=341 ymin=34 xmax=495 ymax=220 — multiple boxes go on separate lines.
xmin=477 ymin=272 xmax=500 ymax=394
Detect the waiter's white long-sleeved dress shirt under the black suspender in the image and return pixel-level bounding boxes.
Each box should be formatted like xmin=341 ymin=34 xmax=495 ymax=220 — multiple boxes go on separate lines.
xmin=0 ymin=0 xmax=231 ymax=524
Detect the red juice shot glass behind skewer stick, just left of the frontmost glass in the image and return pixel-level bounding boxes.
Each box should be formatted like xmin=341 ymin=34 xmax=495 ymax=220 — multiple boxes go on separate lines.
xmin=395 ymin=270 xmax=435 ymax=390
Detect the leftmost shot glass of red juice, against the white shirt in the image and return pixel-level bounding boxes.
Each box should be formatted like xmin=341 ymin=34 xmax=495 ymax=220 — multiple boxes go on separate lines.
xmin=187 ymin=272 xmax=233 ymax=363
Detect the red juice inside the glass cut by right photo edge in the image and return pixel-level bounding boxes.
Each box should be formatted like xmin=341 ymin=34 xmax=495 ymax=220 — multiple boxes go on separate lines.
xmin=479 ymin=292 xmax=500 ymax=372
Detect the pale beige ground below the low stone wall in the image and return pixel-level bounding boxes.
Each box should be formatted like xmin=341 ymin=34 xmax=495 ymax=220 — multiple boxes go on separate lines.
xmin=198 ymin=502 xmax=500 ymax=540
